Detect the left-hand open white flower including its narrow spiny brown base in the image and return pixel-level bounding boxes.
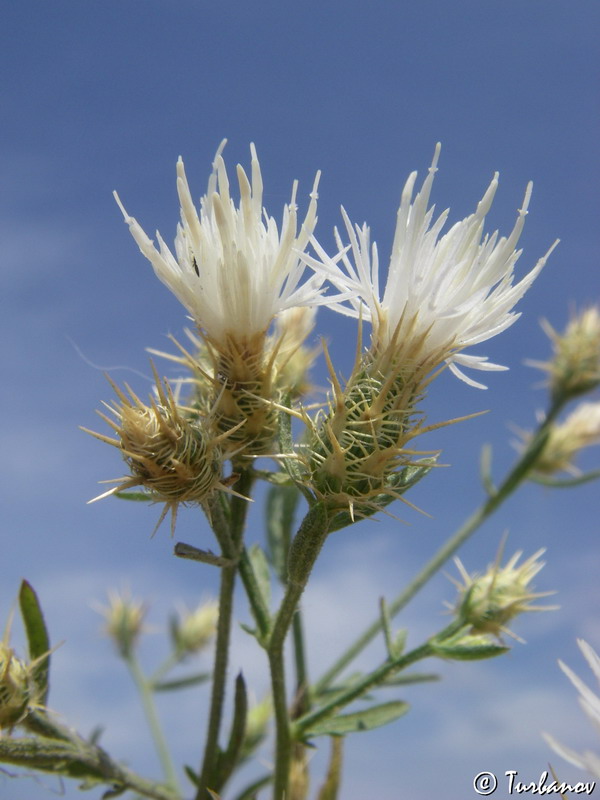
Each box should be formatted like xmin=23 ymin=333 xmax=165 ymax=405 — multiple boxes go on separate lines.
xmin=117 ymin=141 xmax=338 ymax=455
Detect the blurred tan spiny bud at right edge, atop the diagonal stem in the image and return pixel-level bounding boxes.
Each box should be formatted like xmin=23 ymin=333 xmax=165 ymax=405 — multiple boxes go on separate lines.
xmin=527 ymin=306 xmax=600 ymax=398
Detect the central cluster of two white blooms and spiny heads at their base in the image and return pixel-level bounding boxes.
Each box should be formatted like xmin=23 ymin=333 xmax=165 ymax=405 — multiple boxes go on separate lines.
xmin=90 ymin=142 xmax=552 ymax=532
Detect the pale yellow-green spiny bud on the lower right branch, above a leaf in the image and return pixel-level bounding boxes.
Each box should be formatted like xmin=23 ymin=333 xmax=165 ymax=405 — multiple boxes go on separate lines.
xmin=452 ymin=549 xmax=557 ymax=640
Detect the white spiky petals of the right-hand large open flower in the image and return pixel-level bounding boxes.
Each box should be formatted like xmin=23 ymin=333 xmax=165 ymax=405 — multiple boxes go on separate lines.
xmin=310 ymin=144 xmax=557 ymax=388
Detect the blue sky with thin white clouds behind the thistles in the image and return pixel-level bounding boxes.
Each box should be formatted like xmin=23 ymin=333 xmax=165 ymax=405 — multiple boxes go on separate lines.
xmin=0 ymin=0 xmax=600 ymax=800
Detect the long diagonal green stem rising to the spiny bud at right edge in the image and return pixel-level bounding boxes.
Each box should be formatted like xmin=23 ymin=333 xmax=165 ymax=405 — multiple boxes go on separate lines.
xmin=314 ymin=398 xmax=566 ymax=694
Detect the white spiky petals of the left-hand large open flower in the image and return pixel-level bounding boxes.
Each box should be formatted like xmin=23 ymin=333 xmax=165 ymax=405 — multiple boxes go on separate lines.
xmin=115 ymin=140 xmax=324 ymax=347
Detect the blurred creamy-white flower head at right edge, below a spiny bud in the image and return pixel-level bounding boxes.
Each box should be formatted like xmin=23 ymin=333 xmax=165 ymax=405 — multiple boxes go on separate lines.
xmin=522 ymin=403 xmax=600 ymax=475
